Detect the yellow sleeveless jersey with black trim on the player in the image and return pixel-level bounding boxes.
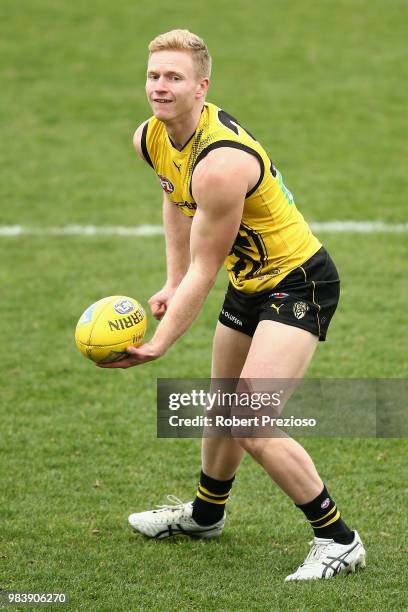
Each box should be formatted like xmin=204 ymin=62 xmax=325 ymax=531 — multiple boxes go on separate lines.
xmin=141 ymin=103 xmax=321 ymax=294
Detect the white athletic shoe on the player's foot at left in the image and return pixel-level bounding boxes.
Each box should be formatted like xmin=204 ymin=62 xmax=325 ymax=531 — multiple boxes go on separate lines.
xmin=128 ymin=495 xmax=226 ymax=540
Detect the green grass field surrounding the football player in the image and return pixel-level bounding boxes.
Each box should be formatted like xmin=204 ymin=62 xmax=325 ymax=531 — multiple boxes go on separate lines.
xmin=0 ymin=0 xmax=408 ymax=611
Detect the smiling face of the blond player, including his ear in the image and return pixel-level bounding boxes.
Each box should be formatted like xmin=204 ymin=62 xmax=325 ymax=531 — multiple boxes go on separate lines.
xmin=146 ymin=51 xmax=208 ymax=122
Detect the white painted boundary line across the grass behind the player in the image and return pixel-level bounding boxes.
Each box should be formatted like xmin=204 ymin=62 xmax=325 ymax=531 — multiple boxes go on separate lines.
xmin=0 ymin=221 xmax=408 ymax=237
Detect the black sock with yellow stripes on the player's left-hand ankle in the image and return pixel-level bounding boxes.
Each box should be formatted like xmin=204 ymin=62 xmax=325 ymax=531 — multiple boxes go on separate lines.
xmin=192 ymin=471 xmax=235 ymax=525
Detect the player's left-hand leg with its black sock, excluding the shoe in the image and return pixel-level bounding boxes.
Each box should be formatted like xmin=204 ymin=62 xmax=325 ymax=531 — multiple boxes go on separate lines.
xmin=192 ymin=322 xmax=252 ymax=525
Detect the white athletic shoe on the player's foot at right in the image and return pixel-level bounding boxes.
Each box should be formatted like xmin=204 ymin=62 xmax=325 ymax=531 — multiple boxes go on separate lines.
xmin=285 ymin=531 xmax=366 ymax=580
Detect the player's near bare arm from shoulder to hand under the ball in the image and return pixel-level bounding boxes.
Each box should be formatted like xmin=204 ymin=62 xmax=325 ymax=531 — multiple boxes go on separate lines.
xmin=99 ymin=149 xmax=250 ymax=368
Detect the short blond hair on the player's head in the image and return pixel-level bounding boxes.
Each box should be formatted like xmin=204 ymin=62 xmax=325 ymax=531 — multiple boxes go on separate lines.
xmin=149 ymin=30 xmax=211 ymax=79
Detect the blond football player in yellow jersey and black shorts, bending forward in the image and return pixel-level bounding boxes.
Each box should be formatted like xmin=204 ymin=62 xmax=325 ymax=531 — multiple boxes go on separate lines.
xmin=99 ymin=30 xmax=365 ymax=580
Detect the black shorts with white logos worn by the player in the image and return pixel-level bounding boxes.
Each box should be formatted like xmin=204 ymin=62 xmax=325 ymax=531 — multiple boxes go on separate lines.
xmin=218 ymin=247 xmax=340 ymax=341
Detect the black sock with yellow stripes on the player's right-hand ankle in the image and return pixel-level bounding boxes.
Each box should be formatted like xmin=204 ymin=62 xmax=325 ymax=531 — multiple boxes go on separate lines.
xmin=296 ymin=487 xmax=354 ymax=544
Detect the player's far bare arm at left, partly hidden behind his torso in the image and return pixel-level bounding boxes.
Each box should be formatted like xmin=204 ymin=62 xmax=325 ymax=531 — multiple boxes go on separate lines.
xmin=133 ymin=121 xmax=191 ymax=320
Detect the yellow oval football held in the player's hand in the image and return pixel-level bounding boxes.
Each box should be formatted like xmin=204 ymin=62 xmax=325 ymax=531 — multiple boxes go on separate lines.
xmin=75 ymin=295 xmax=147 ymax=363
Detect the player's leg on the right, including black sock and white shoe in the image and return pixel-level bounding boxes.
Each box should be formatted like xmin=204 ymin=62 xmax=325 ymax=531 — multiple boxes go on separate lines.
xmin=234 ymin=321 xmax=365 ymax=580
